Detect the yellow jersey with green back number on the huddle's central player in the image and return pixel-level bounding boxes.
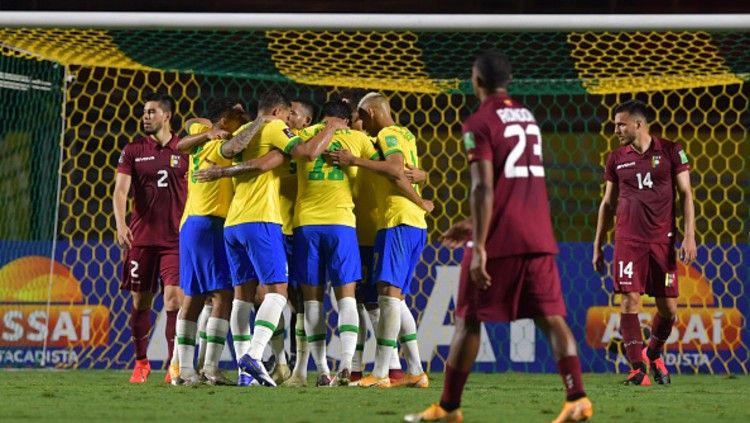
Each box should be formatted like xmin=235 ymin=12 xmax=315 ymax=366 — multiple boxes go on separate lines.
xmin=294 ymin=123 xmax=378 ymax=228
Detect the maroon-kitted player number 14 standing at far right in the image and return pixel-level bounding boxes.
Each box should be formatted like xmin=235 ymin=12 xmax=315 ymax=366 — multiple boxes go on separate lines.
xmin=592 ymin=100 xmax=696 ymax=385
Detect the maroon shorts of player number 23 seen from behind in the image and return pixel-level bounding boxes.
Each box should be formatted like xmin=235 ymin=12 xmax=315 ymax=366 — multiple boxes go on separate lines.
xmin=456 ymin=248 xmax=565 ymax=322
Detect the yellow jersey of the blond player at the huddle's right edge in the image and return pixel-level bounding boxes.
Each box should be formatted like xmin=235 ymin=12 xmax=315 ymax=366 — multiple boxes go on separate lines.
xmin=375 ymin=125 xmax=427 ymax=229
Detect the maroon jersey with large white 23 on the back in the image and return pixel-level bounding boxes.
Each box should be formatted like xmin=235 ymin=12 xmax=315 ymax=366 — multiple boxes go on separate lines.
xmin=463 ymin=94 xmax=557 ymax=257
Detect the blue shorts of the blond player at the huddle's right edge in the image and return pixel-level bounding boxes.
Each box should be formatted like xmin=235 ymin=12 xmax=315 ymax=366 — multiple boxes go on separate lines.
xmin=372 ymin=225 xmax=427 ymax=294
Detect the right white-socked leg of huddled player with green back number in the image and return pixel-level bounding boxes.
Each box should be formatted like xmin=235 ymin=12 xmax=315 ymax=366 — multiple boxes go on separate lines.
xmin=332 ymin=282 xmax=359 ymax=385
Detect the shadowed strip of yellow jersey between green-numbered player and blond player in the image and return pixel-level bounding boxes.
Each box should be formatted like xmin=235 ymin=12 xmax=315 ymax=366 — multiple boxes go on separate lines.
xmin=352 ymin=144 xmax=384 ymax=246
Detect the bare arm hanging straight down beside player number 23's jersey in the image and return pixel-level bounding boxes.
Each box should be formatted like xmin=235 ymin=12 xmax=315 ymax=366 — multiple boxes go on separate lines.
xmin=470 ymin=160 xmax=495 ymax=289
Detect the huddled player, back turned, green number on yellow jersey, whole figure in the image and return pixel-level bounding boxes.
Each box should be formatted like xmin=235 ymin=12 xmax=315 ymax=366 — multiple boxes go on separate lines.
xmin=292 ymin=101 xmax=377 ymax=386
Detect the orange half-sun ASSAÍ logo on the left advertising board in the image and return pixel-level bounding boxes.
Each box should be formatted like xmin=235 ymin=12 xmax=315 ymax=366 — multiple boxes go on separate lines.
xmin=0 ymin=256 xmax=109 ymax=352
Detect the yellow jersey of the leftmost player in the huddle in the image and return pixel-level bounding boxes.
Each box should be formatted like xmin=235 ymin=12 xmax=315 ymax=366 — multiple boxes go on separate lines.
xmin=180 ymin=123 xmax=233 ymax=224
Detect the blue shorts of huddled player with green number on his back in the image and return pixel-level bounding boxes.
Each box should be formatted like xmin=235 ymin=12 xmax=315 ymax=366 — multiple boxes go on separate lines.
xmin=292 ymin=225 xmax=362 ymax=286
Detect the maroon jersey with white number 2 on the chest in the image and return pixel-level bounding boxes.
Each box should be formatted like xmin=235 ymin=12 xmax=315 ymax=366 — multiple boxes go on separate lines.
xmin=117 ymin=135 xmax=188 ymax=248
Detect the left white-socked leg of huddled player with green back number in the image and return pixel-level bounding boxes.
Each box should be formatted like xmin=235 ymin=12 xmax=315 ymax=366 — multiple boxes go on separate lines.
xmin=300 ymin=283 xmax=331 ymax=386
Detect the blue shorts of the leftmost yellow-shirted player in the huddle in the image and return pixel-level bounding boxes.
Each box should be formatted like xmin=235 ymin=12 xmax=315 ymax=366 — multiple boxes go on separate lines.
xmin=180 ymin=216 xmax=232 ymax=296
